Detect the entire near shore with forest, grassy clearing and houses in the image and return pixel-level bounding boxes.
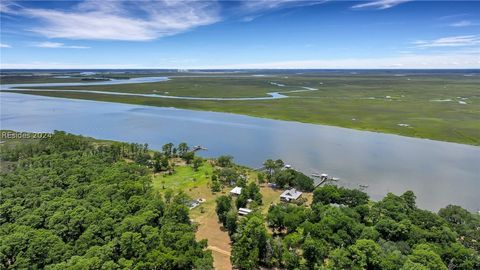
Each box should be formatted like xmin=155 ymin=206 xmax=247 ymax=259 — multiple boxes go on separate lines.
xmin=0 ymin=131 xmax=480 ymax=270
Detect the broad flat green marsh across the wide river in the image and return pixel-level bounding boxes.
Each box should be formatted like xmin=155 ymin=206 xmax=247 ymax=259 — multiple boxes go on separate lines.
xmin=4 ymin=74 xmax=480 ymax=145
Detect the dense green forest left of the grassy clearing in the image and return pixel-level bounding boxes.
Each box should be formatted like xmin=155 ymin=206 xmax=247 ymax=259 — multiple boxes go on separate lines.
xmin=0 ymin=132 xmax=213 ymax=270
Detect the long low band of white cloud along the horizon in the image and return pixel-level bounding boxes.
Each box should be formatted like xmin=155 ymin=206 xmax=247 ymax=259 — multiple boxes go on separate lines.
xmin=0 ymin=50 xmax=480 ymax=69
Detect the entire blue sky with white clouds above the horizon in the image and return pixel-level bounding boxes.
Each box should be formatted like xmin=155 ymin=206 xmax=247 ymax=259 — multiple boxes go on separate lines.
xmin=0 ymin=0 xmax=480 ymax=69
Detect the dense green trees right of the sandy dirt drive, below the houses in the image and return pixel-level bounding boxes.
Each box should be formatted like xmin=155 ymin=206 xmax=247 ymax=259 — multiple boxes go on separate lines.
xmin=217 ymin=182 xmax=480 ymax=270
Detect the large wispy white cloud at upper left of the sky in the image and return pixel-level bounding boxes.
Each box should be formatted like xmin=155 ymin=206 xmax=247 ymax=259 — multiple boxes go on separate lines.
xmin=22 ymin=0 xmax=219 ymax=41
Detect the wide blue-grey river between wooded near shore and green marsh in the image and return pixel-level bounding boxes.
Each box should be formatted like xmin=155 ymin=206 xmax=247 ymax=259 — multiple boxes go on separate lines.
xmin=0 ymin=93 xmax=480 ymax=211
